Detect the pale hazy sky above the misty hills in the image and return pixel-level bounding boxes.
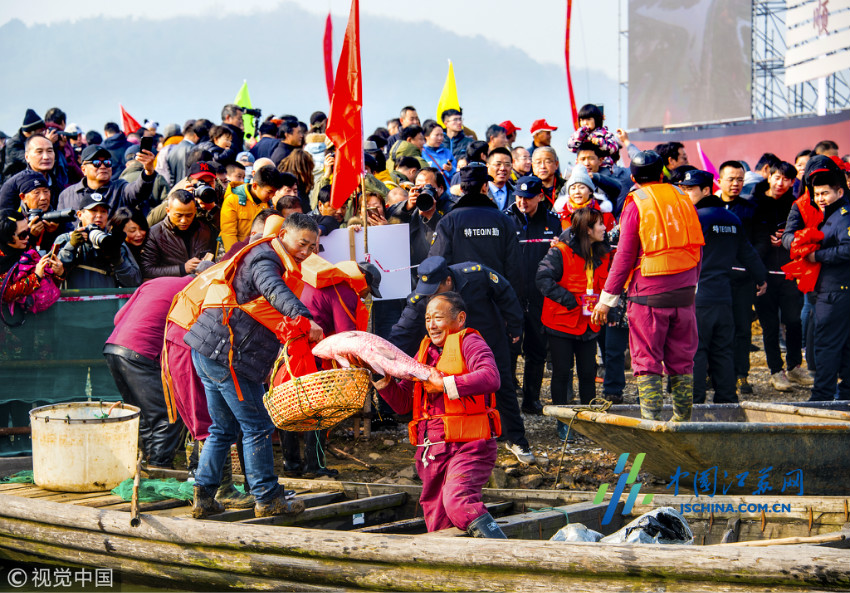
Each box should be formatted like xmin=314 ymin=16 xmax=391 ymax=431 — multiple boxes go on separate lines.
xmin=0 ymin=0 xmax=626 ymax=80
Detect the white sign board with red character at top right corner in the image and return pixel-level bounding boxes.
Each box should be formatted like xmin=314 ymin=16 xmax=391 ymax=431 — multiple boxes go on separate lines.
xmin=785 ymin=0 xmax=850 ymax=86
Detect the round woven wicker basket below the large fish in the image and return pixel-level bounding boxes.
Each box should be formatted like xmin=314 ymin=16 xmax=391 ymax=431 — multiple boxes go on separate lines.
xmin=263 ymin=348 xmax=371 ymax=432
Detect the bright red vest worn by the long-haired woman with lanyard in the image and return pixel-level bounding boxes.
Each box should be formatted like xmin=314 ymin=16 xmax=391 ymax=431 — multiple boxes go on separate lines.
xmin=540 ymin=241 xmax=611 ymax=336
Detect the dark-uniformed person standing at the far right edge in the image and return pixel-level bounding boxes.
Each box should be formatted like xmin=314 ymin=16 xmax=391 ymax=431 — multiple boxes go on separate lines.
xmin=809 ymin=171 xmax=850 ymax=401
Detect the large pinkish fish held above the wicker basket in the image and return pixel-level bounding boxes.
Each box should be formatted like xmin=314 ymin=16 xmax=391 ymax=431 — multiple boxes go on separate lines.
xmin=313 ymin=331 xmax=431 ymax=381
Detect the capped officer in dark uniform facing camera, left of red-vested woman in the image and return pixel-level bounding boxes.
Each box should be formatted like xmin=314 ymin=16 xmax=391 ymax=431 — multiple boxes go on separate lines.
xmin=506 ymin=175 xmax=561 ymax=415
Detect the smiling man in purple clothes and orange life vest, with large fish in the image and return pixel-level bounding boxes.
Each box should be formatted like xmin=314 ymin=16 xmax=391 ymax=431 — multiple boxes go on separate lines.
xmin=324 ymin=292 xmax=505 ymax=539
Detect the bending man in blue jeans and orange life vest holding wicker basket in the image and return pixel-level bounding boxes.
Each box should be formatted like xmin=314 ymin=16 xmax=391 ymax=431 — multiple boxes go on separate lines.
xmin=179 ymin=214 xmax=322 ymax=519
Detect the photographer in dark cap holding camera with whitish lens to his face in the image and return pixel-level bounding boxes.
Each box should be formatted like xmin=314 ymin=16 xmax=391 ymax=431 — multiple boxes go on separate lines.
xmin=54 ymin=192 xmax=142 ymax=288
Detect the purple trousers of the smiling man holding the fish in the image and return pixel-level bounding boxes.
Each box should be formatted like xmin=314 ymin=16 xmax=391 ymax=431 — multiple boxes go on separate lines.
xmin=416 ymin=439 xmax=498 ymax=531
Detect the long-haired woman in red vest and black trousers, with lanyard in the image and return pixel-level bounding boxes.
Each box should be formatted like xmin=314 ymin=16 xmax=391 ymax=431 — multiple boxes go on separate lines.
xmin=537 ymin=208 xmax=610 ymax=434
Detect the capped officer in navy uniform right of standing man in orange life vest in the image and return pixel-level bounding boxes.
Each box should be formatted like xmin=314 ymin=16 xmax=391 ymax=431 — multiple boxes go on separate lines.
xmin=679 ymin=169 xmax=767 ymax=404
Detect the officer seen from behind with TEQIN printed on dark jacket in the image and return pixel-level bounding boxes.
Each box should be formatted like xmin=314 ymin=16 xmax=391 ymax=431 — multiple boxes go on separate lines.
xmin=428 ymin=163 xmax=522 ymax=304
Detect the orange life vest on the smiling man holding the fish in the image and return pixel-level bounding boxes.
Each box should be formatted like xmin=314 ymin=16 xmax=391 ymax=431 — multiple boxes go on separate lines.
xmin=407 ymin=329 xmax=502 ymax=444
